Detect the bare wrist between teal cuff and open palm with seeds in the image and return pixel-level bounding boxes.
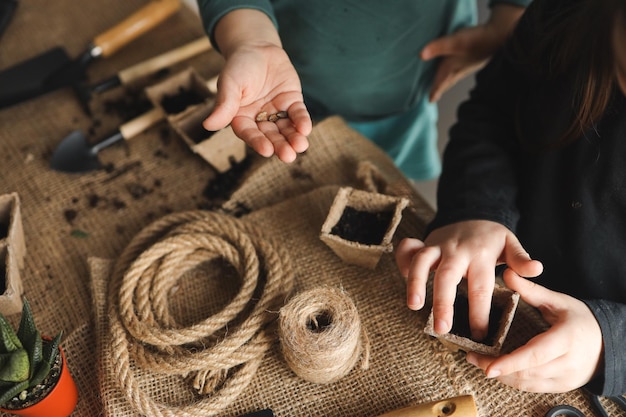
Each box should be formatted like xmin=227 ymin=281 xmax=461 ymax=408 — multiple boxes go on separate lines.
xmin=214 ymin=9 xmax=282 ymax=57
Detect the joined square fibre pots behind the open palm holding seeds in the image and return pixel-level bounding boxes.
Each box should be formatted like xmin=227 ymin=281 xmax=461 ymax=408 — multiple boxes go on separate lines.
xmin=146 ymin=68 xmax=247 ymax=173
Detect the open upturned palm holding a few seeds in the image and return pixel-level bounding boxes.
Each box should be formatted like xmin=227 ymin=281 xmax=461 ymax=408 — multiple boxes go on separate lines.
xmin=203 ymin=45 xmax=312 ymax=162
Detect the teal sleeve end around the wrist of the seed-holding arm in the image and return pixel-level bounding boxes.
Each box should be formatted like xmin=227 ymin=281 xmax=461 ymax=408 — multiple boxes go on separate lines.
xmin=197 ymin=0 xmax=278 ymax=50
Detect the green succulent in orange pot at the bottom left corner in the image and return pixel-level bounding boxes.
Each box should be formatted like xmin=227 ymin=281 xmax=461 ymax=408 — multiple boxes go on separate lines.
xmin=0 ymin=299 xmax=78 ymax=417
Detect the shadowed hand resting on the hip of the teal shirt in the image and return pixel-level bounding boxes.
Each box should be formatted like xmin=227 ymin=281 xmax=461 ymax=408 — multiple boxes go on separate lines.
xmin=421 ymin=4 xmax=524 ymax=102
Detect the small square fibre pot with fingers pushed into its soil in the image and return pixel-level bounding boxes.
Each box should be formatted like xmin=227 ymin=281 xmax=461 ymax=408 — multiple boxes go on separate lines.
xmin=424 ymin=280 xmax=520 ymax=356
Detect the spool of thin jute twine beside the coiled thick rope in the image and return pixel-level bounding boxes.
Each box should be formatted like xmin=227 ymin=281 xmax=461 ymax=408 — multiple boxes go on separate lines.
xmin=278 ymin=287 xmax=370 ymax=384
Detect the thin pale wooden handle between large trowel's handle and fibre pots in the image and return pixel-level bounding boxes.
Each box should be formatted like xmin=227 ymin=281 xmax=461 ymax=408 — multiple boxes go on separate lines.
xmin=117 ymin=36 xmax=211 ymax=84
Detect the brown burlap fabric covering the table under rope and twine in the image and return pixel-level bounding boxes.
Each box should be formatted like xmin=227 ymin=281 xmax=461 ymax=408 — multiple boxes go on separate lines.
xmin=0 ymin=0 xmax=623 ymax=416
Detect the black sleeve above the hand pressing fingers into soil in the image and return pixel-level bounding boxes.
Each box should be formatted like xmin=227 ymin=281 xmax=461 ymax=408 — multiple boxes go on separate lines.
xmin=427 ymin=48 xmax=522 ymax=236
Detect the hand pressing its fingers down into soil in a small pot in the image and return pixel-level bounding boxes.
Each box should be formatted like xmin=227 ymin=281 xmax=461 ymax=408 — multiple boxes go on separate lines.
xmin=396 ymin=220 xmax=543 ymax=340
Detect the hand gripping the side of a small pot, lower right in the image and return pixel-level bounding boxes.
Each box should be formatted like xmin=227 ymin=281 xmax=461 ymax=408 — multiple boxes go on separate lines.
xmin=467 ymin=270 xmax=603 ymax=393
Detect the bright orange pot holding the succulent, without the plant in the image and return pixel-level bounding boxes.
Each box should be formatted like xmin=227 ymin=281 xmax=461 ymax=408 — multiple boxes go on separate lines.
xmin=0 ymin=347 xmax=78 ymax=417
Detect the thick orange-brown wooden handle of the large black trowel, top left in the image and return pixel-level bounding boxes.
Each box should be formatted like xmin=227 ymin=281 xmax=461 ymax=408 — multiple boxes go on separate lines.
xmin=93 ymin=0 xmax=180 ymax=58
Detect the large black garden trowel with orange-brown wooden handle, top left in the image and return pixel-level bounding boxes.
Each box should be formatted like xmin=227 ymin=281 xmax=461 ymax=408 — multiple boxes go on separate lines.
xmin=0 ymin=0 xmax=180 ymax=108
